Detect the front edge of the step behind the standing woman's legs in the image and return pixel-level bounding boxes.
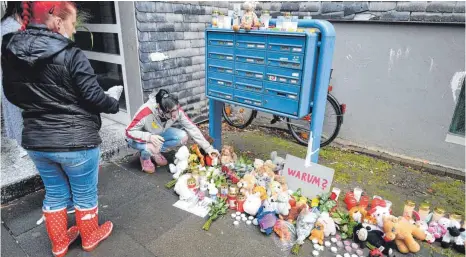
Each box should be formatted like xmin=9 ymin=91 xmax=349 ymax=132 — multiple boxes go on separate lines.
xmin=1 ymin=144 xmax=128 ymax=204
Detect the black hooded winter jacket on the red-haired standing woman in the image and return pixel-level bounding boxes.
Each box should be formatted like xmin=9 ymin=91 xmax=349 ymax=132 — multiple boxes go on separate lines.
xmin=2 ymin=25 xmax=119 ymax=152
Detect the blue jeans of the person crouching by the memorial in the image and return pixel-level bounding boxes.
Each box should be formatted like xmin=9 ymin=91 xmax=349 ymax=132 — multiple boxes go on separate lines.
xmin=128 ymin=128 xmax=188 ymax=160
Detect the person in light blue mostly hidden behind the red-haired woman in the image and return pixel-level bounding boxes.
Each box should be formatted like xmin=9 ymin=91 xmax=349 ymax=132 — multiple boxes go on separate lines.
xmin=2 ymin=1 xmax=27 ymax=157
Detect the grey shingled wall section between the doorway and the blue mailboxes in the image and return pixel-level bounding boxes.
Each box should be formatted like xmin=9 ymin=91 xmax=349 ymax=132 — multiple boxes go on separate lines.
xmin=135 ymin=2 xmax=228 ymax=122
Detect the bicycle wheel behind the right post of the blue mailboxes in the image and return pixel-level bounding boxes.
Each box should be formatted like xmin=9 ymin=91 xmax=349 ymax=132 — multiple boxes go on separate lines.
xmin=286 ymin=94 xmax=343 ymax=147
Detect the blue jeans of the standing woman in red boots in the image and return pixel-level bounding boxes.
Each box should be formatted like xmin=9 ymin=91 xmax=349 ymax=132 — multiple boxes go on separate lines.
xmin=28 ymin=148 xmax=100 ymax=211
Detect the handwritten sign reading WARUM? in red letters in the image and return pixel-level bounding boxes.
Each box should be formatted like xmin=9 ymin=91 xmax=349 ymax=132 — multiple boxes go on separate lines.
xmin=281 ymin=154 xmax=335 ymax=198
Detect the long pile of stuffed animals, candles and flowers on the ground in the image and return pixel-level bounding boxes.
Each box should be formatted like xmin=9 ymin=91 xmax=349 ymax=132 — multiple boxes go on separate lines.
xmin=166 ymin=143 xmax=466 ymax=256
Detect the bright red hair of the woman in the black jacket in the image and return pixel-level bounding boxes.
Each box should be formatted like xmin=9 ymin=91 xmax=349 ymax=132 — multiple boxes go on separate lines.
xmin=21 ymin=1 xmax=76 ymax=30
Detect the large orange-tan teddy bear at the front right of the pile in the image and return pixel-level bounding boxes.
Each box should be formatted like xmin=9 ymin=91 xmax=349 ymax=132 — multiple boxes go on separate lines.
xmin=383 ymin=216 xmax=426 ymax=253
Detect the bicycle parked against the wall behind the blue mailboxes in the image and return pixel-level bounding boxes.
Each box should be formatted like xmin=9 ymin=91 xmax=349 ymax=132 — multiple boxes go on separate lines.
xmin=222 ymin=70 xmax=346 ymax=147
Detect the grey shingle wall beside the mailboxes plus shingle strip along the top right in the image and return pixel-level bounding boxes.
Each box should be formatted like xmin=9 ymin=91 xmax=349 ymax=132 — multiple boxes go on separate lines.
xmin=135 ymin=1 xmax=465 ymax=122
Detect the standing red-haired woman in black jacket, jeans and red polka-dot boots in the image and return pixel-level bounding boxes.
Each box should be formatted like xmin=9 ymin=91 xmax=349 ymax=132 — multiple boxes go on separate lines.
xmin=2 ymin=1 xmax=123 ymax=256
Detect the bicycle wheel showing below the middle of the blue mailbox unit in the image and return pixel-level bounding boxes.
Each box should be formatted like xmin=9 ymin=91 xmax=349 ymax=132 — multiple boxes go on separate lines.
xmin=222 ymin=103 xmax=257 ymax=129
